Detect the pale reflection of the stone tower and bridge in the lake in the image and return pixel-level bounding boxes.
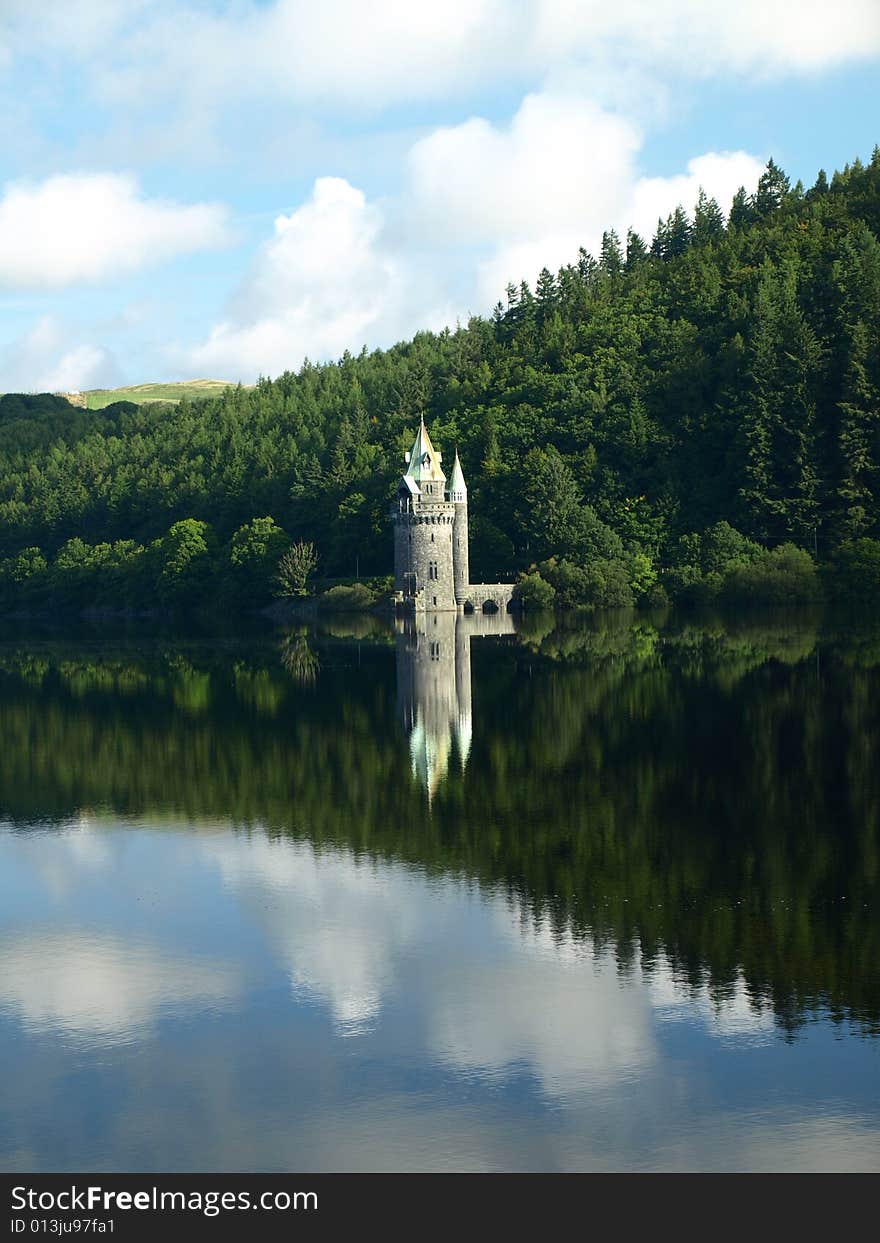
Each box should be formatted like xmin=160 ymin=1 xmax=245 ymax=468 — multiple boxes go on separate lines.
xmin=396 ymin=612 xmax=516 ymax=803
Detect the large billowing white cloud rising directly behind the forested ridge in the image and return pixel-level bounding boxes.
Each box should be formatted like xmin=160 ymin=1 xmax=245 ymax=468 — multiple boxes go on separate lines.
xmin=180 ymin=93 xmax=762 ymax=380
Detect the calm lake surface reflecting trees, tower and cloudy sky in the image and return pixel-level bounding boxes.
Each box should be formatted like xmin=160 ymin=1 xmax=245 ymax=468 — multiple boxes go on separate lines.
xmin=0 ymin=614 xmax=880 ymax=1171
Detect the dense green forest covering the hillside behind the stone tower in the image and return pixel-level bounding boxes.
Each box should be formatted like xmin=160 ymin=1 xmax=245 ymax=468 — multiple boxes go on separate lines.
xmin=0 ymin=148 xmax=880 ymax=614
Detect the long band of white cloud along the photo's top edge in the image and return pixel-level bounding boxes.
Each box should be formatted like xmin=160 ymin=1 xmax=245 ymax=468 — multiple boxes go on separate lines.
xmin=8 ymin=0 xmax=880 ymax=118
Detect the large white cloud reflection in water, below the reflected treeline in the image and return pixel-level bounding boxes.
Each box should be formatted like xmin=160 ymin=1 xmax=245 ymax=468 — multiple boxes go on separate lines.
xmin=198 ymin=835 xmax=655 ymax=1095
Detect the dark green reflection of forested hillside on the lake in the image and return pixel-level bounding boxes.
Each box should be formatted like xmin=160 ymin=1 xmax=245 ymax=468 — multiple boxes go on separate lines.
xmin=0 ymin=613 xmax=880 ymax=1038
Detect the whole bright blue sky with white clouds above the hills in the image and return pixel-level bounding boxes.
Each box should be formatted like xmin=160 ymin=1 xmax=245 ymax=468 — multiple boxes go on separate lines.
xmin=0 ymin=0 xmax=880 ymax=390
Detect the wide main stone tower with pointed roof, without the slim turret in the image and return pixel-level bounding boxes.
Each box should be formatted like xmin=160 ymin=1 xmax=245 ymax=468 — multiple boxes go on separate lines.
xmin=392 ymin=419 xmax=457 ymax=612
